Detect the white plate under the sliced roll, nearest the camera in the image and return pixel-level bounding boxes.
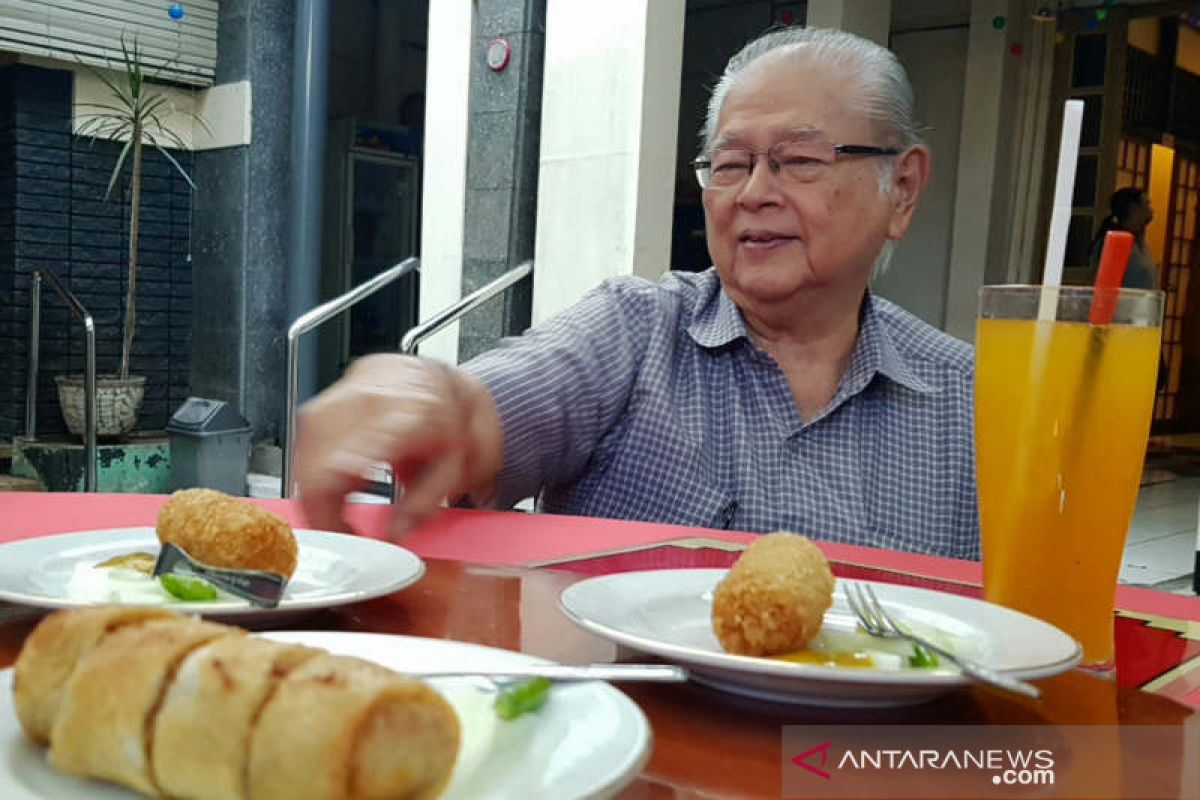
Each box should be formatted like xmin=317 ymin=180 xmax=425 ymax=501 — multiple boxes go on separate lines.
xmin=0 ymin=631 xmax=650 ymax=800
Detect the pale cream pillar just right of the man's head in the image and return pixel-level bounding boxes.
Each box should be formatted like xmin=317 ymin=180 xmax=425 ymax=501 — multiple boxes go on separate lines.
xmin=946 ymin=0 xmax=1012 ymax=342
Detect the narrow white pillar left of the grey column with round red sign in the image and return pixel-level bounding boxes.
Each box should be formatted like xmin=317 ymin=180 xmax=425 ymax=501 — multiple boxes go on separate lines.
xmin=420 ymin=0 xmax=475 ymax=363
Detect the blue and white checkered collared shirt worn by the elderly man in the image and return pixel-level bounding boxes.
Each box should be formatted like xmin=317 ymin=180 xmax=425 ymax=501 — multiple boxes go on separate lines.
xmin=466 ymin=269 xmax=979 ymax=559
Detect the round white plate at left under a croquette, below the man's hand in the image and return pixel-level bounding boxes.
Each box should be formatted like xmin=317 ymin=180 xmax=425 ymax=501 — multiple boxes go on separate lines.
xmin=0 ymin=528 xmax=425 ymax=624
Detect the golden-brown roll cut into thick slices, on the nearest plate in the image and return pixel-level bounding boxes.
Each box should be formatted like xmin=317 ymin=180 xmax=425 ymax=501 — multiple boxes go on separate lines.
xmin=17 ymin=608 xmax=461 ymax=800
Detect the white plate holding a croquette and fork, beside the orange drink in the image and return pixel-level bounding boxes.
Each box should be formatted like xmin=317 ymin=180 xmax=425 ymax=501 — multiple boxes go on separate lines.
xmin=560 ymin=570 xmax=1082 ymax=706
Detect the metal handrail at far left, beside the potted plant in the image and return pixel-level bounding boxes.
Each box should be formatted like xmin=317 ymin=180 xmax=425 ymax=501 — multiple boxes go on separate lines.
xmin=25 ymin=270 xmax=96 ymax=492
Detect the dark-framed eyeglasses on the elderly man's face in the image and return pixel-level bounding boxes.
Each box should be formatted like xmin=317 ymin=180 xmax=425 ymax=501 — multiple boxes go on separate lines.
xmin=691 ymin=138 xmax=900 ymax=188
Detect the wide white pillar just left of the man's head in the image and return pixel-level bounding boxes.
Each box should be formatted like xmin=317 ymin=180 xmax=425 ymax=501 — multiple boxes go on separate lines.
xmin=533 ymin=0 xmax=684 ymax=324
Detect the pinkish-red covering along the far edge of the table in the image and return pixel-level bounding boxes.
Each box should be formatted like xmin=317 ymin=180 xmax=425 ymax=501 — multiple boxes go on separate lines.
xmin=0 ymin=492 xmax=1200 ymax=708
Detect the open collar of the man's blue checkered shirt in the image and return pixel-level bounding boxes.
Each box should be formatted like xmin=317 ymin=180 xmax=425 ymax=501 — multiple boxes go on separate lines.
xmin=688 ymin=276 xmax=934 ymax=395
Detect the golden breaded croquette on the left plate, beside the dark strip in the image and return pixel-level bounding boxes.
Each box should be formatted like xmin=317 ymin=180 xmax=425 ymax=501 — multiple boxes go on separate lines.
xmin=157 ymin=489 xmax=296 ymax=578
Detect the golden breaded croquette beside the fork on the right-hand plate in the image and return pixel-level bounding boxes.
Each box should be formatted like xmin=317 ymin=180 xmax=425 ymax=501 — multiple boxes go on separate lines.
xmin=713 ymin=533 xmax=833 ymax=656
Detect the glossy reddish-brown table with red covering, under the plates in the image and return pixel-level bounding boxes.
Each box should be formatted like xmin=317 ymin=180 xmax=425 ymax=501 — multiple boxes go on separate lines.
xmin=0 ymin=493 xmax=1200 ymax=800
